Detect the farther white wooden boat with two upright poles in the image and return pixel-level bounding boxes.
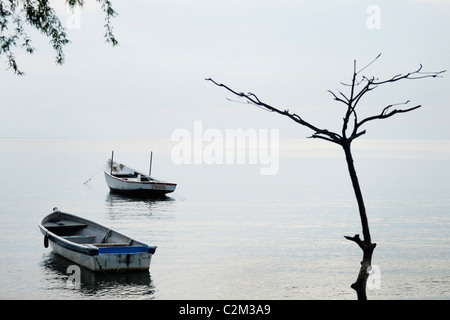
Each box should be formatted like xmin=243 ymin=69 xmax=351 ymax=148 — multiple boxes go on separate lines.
xmin=105 ymin=152 xmax=177 ymax=197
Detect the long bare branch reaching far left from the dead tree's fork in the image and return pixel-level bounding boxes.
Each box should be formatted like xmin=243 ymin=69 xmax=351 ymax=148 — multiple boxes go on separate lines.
xmin=205 ymin=78 xmax=342 ymax=144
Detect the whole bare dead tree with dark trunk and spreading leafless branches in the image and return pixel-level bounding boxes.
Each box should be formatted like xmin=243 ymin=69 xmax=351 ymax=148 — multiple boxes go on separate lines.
xmin=206 ymin=54 xmax=445 ymax=300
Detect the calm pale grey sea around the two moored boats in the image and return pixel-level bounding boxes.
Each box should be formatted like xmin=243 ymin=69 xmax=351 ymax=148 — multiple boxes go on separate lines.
xmin=0 ymin=139 xmax=450 ymax=300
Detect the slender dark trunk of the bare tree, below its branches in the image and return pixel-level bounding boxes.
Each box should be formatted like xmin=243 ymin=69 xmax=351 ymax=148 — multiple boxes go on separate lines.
xmin=342 ymin=141 xmax=376 ymax=300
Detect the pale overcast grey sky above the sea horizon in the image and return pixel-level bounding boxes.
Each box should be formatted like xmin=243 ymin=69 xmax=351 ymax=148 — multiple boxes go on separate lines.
xmin=0 ymin=0 xmax=450 ymax=139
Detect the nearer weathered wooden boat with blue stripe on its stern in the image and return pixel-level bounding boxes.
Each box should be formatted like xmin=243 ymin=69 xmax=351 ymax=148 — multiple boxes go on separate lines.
xmin=39 ymin=208 xmax=156 ymax=271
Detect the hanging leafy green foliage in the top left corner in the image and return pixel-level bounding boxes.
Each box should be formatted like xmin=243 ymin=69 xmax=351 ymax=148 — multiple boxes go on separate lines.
xmin=0 ymin=0 xmax=118 ymax=75
